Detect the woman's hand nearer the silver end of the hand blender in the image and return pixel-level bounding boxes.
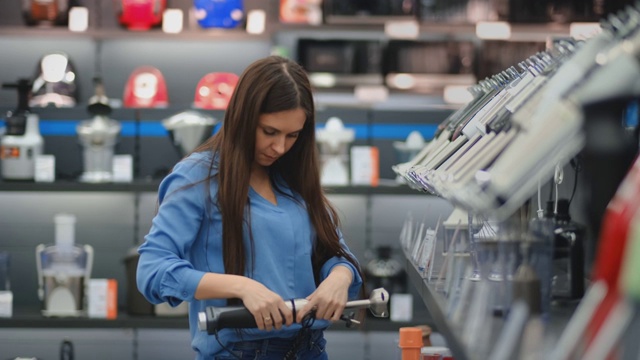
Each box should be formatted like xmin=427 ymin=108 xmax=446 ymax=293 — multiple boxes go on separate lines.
xmin=296 ymin=265 xmax=353 ymax=322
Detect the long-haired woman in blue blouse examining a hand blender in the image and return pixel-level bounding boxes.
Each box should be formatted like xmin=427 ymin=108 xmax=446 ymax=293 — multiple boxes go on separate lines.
xmin=138 ymin=56 xmax=362 ymax=359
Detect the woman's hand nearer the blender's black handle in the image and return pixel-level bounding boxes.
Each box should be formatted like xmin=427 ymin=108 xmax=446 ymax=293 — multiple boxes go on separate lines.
xmin=241 ymin=279 xmax=293 ymax=331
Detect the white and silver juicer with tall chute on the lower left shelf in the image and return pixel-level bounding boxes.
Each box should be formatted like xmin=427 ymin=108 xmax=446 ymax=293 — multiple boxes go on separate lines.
xmin=36 ymin=214 xmax=93 ymax=317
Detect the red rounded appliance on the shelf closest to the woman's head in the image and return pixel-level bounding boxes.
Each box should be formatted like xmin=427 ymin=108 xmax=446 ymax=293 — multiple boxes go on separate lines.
xmin=193 ymin=72 xmax=239 ymax=110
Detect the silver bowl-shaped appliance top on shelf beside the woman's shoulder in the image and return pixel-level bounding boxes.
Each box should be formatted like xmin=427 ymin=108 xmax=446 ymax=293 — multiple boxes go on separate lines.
xmin=162 ymin=110 xmax=218 ymax=156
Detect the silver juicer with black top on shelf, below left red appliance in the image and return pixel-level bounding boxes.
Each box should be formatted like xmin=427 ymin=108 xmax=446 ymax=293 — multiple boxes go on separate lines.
xmin=76 ymin=79 xmax=121 ymax=183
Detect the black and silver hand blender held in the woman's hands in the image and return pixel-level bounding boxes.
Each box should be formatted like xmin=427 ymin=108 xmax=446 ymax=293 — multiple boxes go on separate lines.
xmin=198 ymin=288 xmax=389 ymax=335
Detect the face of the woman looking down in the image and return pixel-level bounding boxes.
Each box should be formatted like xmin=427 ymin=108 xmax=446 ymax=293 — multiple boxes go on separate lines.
xmin=254 ymin=108 xmax=307 ymax=166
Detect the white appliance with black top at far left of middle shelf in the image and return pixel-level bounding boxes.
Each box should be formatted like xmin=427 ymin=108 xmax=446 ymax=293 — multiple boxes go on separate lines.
xmin=0 ymin=79 xmax=44 ymax=180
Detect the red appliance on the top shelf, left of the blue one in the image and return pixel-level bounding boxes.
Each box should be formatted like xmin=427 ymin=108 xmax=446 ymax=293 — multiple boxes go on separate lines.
xmin=116 ymin=0 xmax=167 ymax=31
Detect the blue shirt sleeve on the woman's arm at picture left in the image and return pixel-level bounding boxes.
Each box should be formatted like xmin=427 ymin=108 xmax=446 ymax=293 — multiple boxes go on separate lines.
xmin=137 ymin=159 xmax=208 ymax=306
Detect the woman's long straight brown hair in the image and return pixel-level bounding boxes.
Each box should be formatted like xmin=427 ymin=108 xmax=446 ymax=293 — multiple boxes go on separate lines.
xmin=194 ymin=56 xmax=362 ymax=283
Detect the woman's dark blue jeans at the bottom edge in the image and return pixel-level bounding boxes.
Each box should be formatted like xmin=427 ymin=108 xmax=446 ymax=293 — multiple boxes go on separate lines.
xmin=215 ymin=330 xmax=328 ymax=360
